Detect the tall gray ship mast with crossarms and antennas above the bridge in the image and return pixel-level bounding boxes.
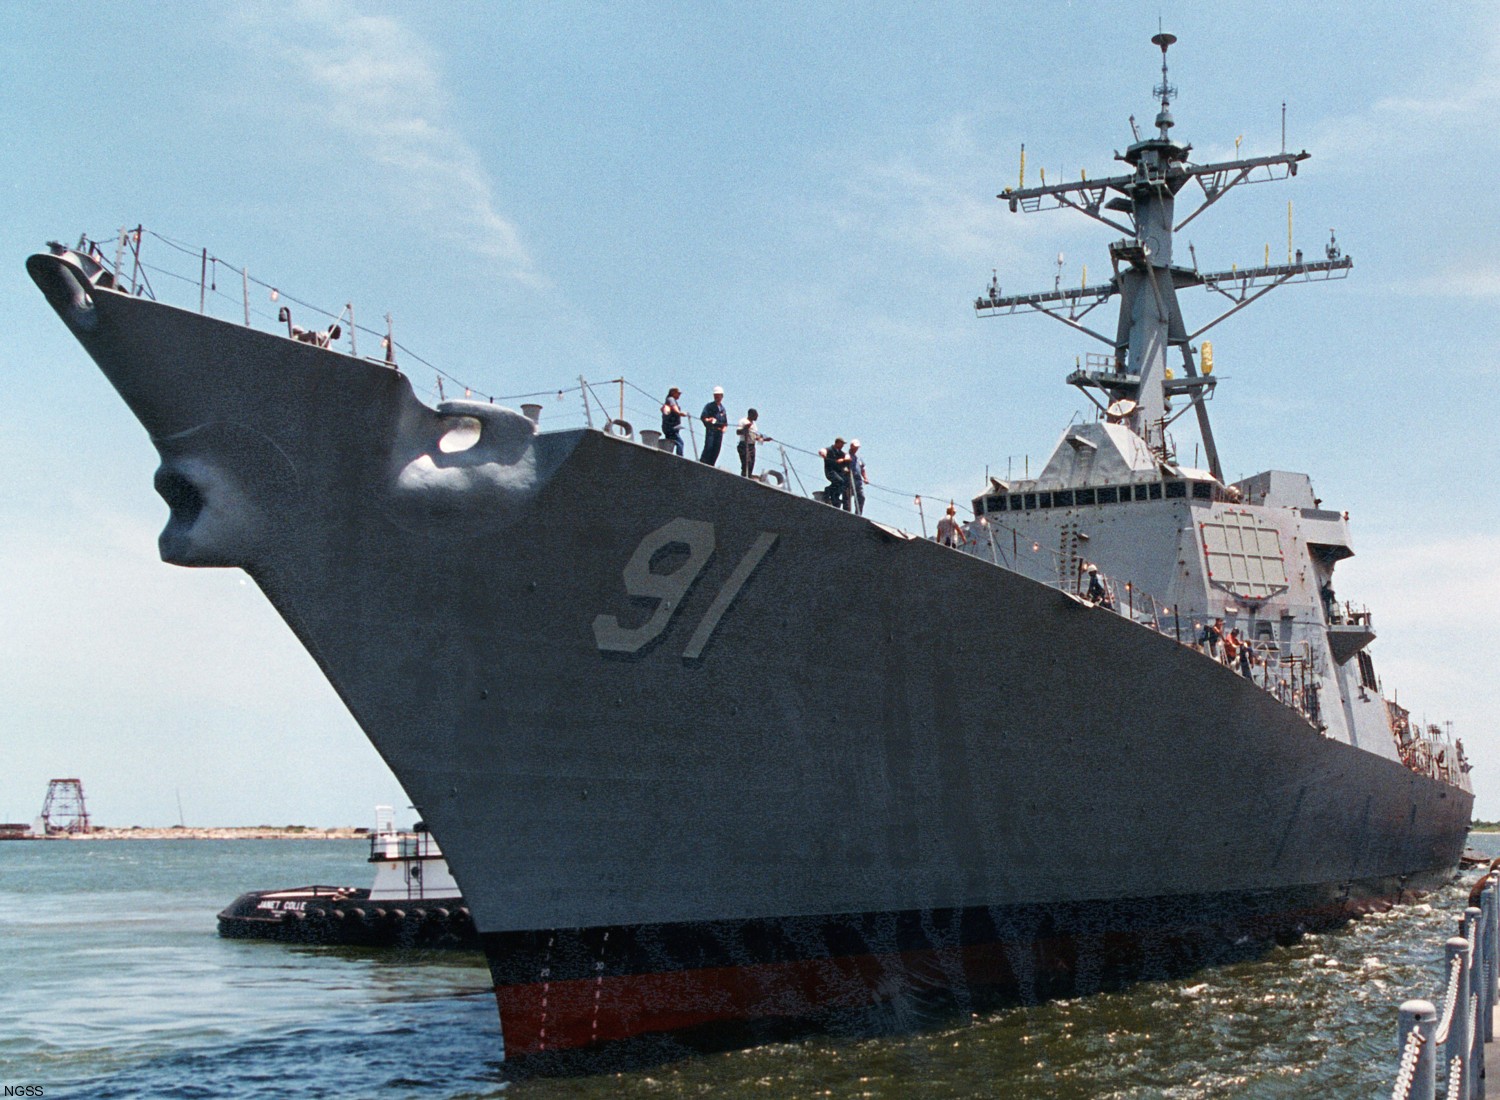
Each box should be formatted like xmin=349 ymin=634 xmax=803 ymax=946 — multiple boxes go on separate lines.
xmin=974 ymin=32 xmax=1353 ymax=482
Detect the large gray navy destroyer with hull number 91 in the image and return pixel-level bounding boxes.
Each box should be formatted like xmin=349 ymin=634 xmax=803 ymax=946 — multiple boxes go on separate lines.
xmin=27 ymin=35 xmax=1473 ymax=1065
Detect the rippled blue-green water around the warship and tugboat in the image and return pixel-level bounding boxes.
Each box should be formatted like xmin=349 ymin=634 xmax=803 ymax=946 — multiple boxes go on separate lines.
xmin=0 ymin=837 xmax=1500 ymax=1100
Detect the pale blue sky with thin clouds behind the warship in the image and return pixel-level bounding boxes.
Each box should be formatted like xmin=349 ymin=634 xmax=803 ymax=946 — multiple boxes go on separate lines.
xmin=0 ymin=0 xmax=1500 ymax=825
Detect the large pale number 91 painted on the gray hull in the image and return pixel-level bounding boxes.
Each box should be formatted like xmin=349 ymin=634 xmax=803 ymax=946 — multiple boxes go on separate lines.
xmin=594 ymin=518 xmax=779 ymax=660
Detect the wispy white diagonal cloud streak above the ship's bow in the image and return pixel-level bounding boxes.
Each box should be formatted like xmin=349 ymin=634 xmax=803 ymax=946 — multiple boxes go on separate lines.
xmin=252 ymin=0 xmax=545 ymax=284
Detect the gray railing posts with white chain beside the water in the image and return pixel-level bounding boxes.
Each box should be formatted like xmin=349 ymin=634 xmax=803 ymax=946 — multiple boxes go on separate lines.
xmin=1391 ymin=860 xmax=1500 ymax=1100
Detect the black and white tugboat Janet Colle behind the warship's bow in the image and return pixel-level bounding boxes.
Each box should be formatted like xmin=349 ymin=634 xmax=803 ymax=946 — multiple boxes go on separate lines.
xmin=219 ymin=806 xmax=480 ymax=950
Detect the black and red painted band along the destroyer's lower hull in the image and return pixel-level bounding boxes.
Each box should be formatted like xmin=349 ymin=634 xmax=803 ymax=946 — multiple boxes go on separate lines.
xmin=486 ymin=881 xmax=1431 ymax=1068
